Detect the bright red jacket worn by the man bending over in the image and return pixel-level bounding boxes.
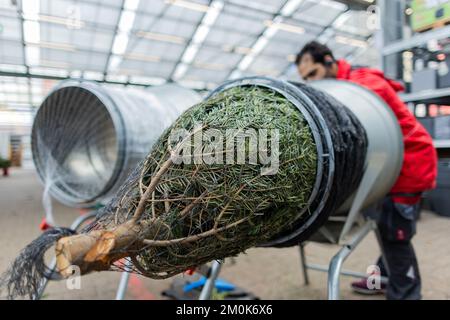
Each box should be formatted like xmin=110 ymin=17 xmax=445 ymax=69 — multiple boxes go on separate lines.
xmin=337 ymin=60 xmax=437 ymax=203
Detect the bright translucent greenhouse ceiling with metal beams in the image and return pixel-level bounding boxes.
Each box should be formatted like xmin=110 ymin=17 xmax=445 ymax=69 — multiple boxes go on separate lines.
xmin=0 ymin=0 xmax=377 ymax=108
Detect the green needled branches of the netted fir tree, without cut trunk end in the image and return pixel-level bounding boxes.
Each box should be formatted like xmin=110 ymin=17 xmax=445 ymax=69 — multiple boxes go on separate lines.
xmin=84 ymin=86 xmax=317 ymax=278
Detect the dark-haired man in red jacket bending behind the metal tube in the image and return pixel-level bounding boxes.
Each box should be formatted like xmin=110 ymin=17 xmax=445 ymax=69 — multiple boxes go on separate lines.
xmin=296 ymin=41 xmax=437 ymax=299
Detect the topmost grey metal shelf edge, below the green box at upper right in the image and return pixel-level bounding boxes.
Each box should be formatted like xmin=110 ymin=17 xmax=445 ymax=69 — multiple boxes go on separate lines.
xmin=381 ymin=25 xmax=450 ymax=56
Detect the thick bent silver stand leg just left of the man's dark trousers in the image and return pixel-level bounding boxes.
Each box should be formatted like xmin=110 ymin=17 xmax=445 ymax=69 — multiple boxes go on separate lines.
xmin=328 ymin=221 xmax=376 ymax=300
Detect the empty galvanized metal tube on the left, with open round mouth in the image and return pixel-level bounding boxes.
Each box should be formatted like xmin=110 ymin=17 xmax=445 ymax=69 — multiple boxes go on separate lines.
xmin=32 ymin=81 xmax=200 ymax=207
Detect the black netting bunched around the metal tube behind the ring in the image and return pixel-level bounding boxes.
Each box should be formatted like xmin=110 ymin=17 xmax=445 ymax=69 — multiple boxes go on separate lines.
xmin=268 ymin=83 xmax=368 ymax=247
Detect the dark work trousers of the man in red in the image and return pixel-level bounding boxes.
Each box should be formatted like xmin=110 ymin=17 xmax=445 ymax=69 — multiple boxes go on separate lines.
xmin=377 ymin=196 xmax=421 ymax=300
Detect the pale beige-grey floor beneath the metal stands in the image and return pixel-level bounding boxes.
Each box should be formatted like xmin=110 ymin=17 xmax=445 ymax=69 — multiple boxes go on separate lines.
xmin=0 ymin=169 xmax=450 ymax=299
